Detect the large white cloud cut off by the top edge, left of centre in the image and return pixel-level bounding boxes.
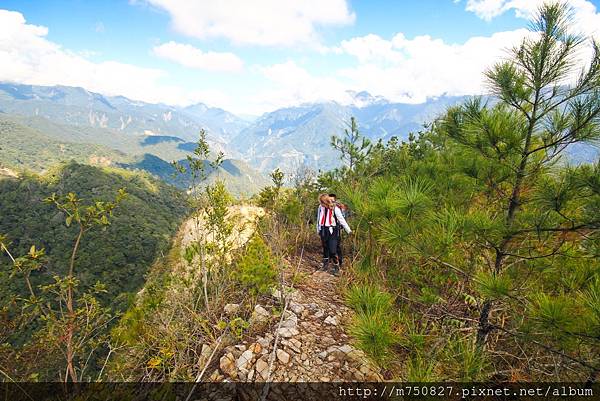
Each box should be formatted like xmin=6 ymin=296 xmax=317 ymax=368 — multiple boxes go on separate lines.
xmin=146 ymin=0 xmax=355 ymax=46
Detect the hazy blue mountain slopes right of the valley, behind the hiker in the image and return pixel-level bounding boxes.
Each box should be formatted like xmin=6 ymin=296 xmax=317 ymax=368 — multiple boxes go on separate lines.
xmin=232 ymin=92 xmax=465 ymax=172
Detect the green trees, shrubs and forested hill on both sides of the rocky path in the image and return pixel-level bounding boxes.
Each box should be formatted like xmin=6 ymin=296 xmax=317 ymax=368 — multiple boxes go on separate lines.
xmin=0 ymin=3 xmax=600 ymax=382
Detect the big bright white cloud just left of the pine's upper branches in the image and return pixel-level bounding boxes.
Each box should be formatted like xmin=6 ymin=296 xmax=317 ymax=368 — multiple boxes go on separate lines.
xmin=332 ymin=29 xmax=528 ymax=103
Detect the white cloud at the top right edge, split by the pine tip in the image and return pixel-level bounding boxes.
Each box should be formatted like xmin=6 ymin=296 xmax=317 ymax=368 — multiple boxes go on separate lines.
xmin=466 ymin=0 xmax=600 ymax=38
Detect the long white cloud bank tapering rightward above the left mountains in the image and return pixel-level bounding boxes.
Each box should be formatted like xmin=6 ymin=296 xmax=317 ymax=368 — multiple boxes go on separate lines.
xmin=0 ymin=10 xmax=228 ymax=106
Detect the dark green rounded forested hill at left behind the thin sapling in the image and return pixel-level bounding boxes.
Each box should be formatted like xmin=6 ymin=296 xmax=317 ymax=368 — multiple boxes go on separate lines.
xmin=0 ymin=163 xmax=186 ymax=303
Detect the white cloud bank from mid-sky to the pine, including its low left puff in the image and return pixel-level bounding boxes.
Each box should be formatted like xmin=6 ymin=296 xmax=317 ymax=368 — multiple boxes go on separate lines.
xmin=255 ymin=29 xmax=530 ymax=110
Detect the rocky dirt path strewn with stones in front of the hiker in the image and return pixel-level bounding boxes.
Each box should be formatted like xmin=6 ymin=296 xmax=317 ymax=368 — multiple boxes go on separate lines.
xmin=210 ymin=241 xmax=382 ymax=382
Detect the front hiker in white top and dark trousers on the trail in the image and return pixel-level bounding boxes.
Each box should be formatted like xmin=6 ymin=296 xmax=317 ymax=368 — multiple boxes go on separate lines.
xmin=317 ymin=194 xmax=352 ymax=276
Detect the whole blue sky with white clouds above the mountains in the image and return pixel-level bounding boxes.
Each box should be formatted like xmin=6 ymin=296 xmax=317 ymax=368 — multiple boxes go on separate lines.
xmin=0 ymin=0 xmax=600 ymax=115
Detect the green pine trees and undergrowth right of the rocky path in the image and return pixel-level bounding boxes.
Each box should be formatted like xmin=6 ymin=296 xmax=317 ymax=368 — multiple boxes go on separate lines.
xmin=328 ymin=3 xmax=600 ymax=380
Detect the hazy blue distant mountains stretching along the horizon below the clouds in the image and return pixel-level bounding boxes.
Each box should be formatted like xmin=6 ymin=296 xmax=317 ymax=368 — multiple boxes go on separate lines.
xmin=0 ymin=83 xmax=597 ymax=190
